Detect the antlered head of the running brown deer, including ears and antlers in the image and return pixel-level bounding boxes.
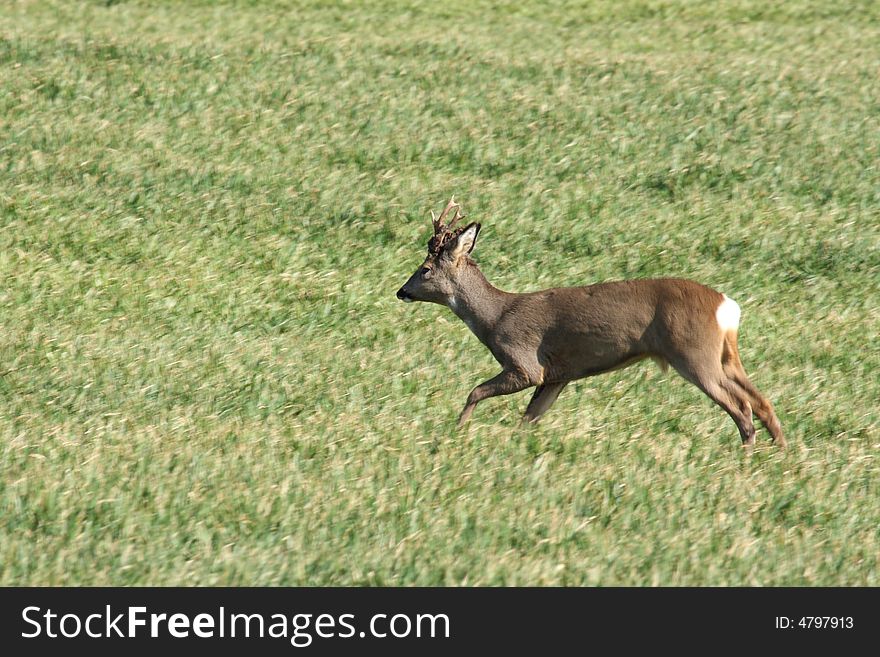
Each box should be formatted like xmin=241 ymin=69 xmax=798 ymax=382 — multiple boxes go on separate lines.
xmin=397 ymin=196 xmax=480 ymax=306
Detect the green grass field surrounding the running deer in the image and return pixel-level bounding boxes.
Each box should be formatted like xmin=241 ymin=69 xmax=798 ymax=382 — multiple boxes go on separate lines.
xmin=0 ymin=0 xmax=880 ymax=586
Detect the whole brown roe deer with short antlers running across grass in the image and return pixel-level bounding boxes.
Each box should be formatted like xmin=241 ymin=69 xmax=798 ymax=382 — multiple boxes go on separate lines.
xmin=397 ymin=197 xmax=785 ymax=447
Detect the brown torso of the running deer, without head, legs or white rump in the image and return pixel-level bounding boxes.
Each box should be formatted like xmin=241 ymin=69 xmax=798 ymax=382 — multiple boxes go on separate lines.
xmin=449 ymin=261 xmax=724 ymax=385
